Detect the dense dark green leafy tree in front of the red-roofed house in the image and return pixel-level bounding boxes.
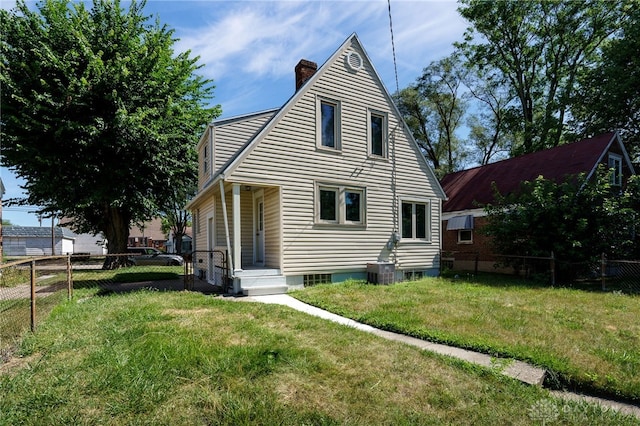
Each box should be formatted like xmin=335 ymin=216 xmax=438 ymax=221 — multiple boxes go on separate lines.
xmin=483 ymin=166 xmax=640 ymax=280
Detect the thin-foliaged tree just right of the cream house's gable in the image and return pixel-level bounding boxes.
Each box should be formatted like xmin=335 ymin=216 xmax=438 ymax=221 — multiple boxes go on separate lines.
xmin=395 ymin=55 xmax=466 ymax=175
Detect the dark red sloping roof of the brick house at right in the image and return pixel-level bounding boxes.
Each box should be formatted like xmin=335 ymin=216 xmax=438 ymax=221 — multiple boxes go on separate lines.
xmin=440 ymin=132 xmax=633 ymax=212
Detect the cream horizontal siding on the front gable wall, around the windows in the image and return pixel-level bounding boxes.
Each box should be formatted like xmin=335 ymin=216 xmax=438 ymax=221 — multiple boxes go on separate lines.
xmin=227 ymin=38 xmax=440 ymax=275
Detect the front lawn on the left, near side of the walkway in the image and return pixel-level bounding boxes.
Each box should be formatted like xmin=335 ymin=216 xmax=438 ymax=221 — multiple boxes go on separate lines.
xmin=0 ymin=290 xmax=637 ymax=425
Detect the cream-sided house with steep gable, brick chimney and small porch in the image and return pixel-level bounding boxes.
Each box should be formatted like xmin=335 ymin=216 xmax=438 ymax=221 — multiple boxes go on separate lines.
xmin=187 ymin=34 xmax=445 ymax=294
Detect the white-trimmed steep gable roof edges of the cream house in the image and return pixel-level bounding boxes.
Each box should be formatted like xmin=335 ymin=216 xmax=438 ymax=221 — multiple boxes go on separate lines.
xmin=186 ymin=33 xmax=446 ymax=209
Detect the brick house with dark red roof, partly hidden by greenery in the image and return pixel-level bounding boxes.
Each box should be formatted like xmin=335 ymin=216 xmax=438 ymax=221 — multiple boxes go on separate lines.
xmin=440 ymin=132 xmax=635 ymax=271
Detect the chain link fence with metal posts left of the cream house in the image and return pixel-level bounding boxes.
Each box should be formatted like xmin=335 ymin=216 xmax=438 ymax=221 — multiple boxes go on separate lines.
xmin=0 ymin=251 xmax=229 ymax=364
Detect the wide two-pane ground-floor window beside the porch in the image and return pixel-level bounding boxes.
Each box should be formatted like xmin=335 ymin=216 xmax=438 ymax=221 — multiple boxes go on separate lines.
xmin=316 ymin=184 xmax=365 ymax=225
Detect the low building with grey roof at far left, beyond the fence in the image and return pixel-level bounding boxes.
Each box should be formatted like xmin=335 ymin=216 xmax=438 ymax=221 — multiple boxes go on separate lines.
xmin=2 ymin=225 xmax=75 ymax=256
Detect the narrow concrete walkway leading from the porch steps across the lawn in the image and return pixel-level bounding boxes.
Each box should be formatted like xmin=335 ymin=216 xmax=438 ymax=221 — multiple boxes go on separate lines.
xmin=244 ymin=294 xmax=640 ymax=418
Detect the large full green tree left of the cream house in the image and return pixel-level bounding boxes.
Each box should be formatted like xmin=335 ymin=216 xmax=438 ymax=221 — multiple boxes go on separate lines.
xmin=0 ymin=0 xmax=219 ymax=266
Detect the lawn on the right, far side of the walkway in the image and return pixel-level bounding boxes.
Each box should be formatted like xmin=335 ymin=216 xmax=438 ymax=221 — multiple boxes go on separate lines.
xmin=292 ymin=276 xmax=640 ymax=401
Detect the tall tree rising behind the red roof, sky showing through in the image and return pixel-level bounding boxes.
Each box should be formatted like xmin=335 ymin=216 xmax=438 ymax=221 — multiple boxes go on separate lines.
xmin=457 ymin=0 xmax=628 ymax=155
